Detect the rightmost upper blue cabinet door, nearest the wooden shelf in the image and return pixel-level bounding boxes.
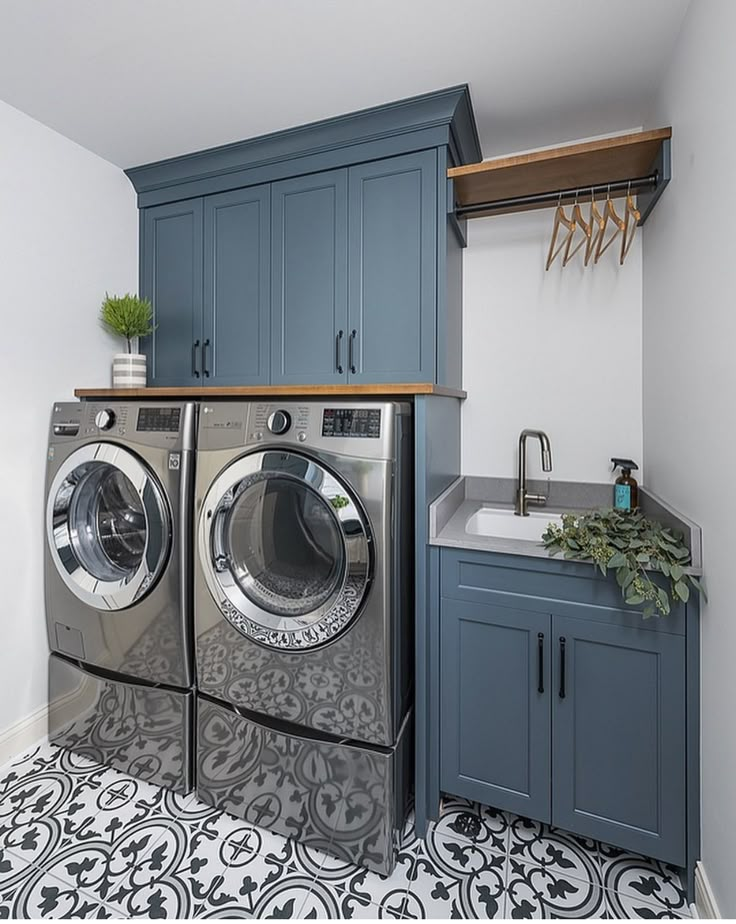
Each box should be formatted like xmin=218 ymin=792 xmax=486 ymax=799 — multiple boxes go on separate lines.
xmin=348 ymin=150 xmax=437 ymax=383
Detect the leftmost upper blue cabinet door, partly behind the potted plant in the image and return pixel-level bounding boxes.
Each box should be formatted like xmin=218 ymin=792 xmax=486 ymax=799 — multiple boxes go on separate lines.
xmin=141 ymin=199 xmax=203 ymax=386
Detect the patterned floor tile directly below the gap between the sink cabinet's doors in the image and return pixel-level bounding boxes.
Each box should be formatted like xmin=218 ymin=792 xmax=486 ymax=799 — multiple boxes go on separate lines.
xmin=509 ymin=818 xmax=603 ymax=886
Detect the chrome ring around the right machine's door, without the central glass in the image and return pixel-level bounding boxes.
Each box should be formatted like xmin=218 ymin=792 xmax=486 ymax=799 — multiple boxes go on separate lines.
xmin=197 ymin=449 xmax=371 ymax=650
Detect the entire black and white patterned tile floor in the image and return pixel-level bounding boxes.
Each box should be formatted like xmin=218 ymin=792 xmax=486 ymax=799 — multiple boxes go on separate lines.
xmin=0 ymin=743 xmax=690 ymax=920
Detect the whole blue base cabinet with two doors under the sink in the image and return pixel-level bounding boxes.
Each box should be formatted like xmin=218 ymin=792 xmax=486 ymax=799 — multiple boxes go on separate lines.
xmin=434 ymin=548 xmax=698 ymax=873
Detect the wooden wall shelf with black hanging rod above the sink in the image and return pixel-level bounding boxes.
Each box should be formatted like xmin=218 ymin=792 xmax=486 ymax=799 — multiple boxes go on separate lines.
xmin=447 ymin=128 xmax=672 ymax=224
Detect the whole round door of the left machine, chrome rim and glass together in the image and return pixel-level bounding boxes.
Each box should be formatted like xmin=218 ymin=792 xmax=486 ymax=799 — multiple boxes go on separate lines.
xmin=47 ymin=443 xmax=170 ymax=609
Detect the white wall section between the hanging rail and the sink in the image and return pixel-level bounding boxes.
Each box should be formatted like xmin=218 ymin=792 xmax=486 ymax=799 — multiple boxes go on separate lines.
xmin=462 ymin=209 xmax=646 ymax=481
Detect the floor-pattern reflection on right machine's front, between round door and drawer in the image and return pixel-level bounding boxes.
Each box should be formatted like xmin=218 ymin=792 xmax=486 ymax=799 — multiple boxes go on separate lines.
xmin=197 ymin=622 xmax=387 ymax=742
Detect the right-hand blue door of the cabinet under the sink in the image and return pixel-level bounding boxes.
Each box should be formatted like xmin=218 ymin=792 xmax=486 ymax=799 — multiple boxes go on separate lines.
xmin=552 ymin=613 xmax=686 ymax=866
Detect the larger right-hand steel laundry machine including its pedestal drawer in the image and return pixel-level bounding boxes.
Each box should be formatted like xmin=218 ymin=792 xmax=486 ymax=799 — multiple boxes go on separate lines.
xmin=195 ymin=400 xmax=413 ymax=873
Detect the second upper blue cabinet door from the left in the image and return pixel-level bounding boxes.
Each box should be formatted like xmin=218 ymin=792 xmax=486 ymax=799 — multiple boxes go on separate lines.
xmin=201 ymin=186 xmax=271 ymax=385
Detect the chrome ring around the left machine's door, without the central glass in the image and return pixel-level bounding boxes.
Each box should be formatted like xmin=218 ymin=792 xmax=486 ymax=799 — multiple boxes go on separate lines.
xmin=46 ymin=443 xmax=171 ymax=610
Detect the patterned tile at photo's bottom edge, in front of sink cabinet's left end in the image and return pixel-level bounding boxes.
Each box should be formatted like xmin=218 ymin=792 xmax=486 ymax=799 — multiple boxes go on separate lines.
xmin=403 ymin=839 xmax=507 ymax=919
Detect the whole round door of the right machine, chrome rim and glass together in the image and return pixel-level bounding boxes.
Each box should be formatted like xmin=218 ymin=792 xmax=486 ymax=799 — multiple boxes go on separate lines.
xmin=200 ymin=451 xmax=370 ymax=649
